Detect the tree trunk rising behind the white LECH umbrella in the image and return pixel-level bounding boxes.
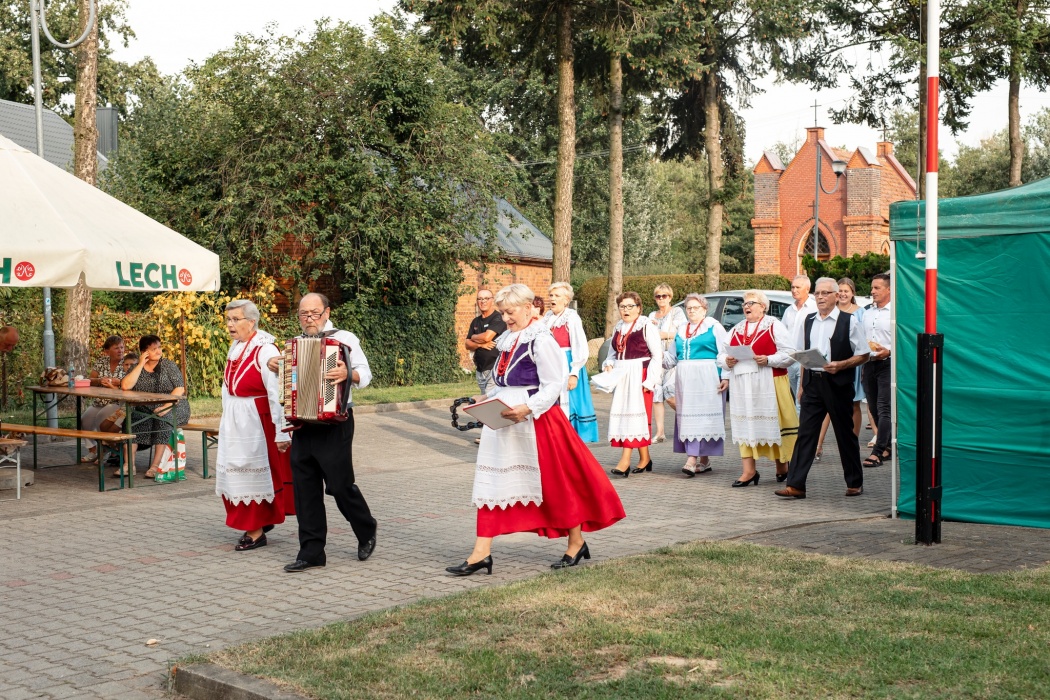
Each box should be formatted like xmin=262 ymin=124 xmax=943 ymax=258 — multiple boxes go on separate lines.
xmin=62 ymin=0 xmax=99 ymax=376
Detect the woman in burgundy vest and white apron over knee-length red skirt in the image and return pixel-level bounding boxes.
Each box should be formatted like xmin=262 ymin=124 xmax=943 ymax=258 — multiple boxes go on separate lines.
xmin=602 ymin=292 xmax=664 ymax=479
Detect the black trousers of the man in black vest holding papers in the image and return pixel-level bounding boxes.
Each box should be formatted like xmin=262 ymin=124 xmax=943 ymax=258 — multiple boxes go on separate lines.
xmin=788 ymin=372 xmax=864 ymax=491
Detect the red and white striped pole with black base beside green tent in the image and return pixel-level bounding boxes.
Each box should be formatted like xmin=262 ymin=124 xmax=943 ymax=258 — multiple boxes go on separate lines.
xmin=916 ymin=0 xmax=944 ymax=545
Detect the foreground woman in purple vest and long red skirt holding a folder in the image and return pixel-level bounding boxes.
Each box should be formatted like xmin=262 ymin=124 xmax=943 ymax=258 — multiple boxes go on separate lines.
xmin=445 ymin=284 xmax=625 ymax=576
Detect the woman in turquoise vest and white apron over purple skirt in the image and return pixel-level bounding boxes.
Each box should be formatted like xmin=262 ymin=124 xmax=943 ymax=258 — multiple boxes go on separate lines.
xmin=664 ymin=294 xmax=729 ymax=478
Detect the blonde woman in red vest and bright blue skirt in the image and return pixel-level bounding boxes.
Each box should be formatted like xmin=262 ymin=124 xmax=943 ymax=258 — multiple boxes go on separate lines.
xmin=543 ymin=282 xmax=597 ymax=443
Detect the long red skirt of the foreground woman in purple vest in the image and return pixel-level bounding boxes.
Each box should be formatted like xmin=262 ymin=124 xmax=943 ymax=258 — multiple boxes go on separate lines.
xmin=478 ymin=405 xmax=626 ymax=538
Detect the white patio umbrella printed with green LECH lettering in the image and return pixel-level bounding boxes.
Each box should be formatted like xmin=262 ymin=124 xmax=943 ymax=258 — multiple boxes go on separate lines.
xmin=0 ymin=135 xmax=219 ymax=292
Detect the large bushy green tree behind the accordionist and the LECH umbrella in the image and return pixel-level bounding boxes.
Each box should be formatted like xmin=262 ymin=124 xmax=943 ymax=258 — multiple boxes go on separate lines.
xmin=107 ymin=16 xmax=508 ymax=381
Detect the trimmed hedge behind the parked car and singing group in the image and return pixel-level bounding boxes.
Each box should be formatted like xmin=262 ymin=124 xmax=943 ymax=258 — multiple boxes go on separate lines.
xmin=576 ymin=274 xmax=791 ymax=338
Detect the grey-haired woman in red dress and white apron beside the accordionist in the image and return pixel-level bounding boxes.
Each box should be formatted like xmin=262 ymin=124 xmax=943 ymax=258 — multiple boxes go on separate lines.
xmin=215 ymin=299 xmax=295 ymax=552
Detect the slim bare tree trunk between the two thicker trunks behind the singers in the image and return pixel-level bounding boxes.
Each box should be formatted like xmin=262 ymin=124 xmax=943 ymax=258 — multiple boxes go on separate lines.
xmin=605 ymin=55 xmax=624 ymax=338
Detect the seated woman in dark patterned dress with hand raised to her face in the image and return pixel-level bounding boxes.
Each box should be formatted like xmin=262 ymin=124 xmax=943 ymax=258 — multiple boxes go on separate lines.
xmin=116 ymin=336 xmax=190 ymax=479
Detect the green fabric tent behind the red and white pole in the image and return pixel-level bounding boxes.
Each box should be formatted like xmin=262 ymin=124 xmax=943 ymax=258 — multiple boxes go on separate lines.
xmin=889 ymin=178 xmax=1050 ymax=528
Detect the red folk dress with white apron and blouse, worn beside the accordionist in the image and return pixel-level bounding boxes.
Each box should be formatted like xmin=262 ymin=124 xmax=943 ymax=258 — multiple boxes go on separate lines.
xmin=215 ymin=332 xmax=295 ymax=532
